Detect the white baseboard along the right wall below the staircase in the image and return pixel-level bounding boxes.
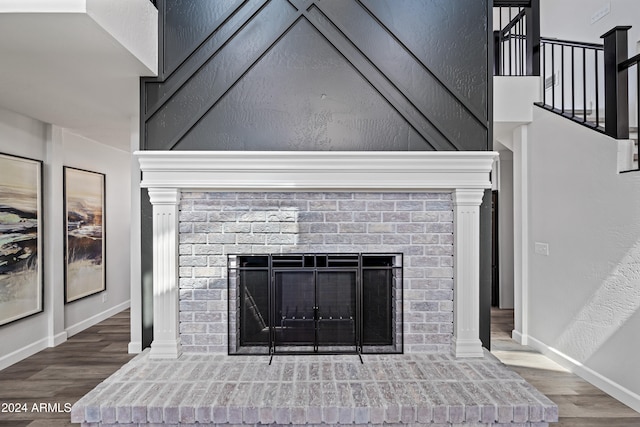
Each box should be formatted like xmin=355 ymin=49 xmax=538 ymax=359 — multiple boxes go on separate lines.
xmin=514 ymin=331 xmax=640 ymax=412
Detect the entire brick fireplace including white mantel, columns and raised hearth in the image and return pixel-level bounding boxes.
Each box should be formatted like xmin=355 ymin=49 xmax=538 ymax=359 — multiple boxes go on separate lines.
xmin=71 ymin=152 xmax=558 ymax=427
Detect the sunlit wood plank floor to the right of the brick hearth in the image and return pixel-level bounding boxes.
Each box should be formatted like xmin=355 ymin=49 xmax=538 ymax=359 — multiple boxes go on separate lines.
xmin=491 ymin=309 xmax=640 ymax=427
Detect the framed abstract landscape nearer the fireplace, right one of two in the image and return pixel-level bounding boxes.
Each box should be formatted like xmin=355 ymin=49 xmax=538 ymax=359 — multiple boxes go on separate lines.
xmin=64 ymin=166 xmax=107 ymax=303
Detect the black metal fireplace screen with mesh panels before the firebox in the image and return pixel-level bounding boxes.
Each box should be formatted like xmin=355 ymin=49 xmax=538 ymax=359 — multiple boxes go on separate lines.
xmin=229 ymin=254 xmax=402 ymax=354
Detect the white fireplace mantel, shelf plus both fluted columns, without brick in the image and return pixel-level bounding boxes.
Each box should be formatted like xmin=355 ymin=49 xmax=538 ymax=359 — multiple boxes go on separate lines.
xmin=135 ymin=151 xmax=498 ymax=358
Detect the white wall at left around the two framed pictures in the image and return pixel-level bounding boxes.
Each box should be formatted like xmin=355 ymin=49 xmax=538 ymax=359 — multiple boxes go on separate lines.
xmin=0 ymin=109 xmax=131 ymax=369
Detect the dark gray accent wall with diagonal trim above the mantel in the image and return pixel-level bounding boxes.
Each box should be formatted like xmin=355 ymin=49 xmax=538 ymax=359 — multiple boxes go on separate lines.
xmin=142 ymin=0 xmax=490 ymax=151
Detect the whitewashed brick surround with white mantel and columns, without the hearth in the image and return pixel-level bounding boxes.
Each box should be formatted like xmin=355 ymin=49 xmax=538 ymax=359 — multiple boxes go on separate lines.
xmin=137 ymin=151 xmax=496 ymax=358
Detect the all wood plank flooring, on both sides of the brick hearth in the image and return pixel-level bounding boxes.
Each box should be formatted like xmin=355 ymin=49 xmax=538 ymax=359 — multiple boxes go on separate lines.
xmin=0 ymin=310 xmax=640 ymax=427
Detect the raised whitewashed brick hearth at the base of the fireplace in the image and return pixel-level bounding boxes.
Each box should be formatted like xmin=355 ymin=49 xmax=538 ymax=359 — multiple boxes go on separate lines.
xmin=71 ymin=352 xmax=558 ymax=427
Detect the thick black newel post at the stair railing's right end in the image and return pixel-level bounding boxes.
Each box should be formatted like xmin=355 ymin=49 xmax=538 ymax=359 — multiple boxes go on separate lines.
xmin=601 ymin=26 xmax=631 ymax=139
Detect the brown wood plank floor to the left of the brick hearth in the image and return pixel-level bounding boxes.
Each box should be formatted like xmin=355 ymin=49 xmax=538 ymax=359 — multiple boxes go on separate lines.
xmin=0 ymin=310 xmax=134 ymax=427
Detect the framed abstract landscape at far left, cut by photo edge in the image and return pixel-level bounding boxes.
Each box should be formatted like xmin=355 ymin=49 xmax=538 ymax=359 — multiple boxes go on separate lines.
xmin=0 ymin=154 xmax=44 ymax=326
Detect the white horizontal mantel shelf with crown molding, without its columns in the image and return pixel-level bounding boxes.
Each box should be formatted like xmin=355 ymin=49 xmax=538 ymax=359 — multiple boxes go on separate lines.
xmin=135 ymin=151 xmax=497 ymax=191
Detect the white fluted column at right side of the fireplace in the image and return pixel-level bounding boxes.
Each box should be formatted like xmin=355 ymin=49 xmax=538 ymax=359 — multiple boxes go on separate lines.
xmin=453 ymin=189 xmax=484 ymax=357
